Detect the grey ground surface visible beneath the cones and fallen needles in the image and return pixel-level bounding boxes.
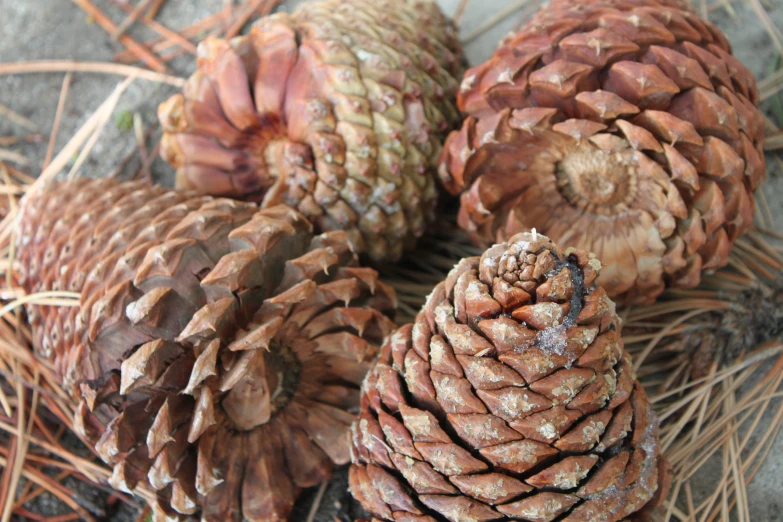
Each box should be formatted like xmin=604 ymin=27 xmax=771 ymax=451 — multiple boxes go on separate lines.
xmin=0 ymin=0 xmax=783 ymax=521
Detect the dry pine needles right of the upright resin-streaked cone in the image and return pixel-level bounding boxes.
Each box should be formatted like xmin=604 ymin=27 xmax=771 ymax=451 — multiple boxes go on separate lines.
xmin=623 ymin=230 xmax=783 ymax=521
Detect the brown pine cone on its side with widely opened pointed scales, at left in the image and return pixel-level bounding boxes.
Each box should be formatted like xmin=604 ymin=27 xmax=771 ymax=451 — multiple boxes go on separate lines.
xmin=17 ymin=180 xmax=395 ymax=522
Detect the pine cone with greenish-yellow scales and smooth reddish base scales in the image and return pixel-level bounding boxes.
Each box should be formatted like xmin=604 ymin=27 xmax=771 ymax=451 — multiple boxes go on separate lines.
xmin=158 ymin=0 xmax=462 ymax=260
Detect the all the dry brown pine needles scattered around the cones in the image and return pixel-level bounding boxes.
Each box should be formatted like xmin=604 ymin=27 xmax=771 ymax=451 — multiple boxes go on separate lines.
xmin=0 ymin=0 xmax=783 ymax=522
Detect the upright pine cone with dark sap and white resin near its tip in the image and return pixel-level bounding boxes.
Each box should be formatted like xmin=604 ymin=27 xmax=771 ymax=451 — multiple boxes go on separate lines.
xmin=350 ymin=232 xmax=667 ymax=522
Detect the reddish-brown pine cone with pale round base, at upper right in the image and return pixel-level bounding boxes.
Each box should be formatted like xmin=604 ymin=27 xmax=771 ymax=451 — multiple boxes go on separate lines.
xmin=439 ymin=0 xmax=766 ymax=303
